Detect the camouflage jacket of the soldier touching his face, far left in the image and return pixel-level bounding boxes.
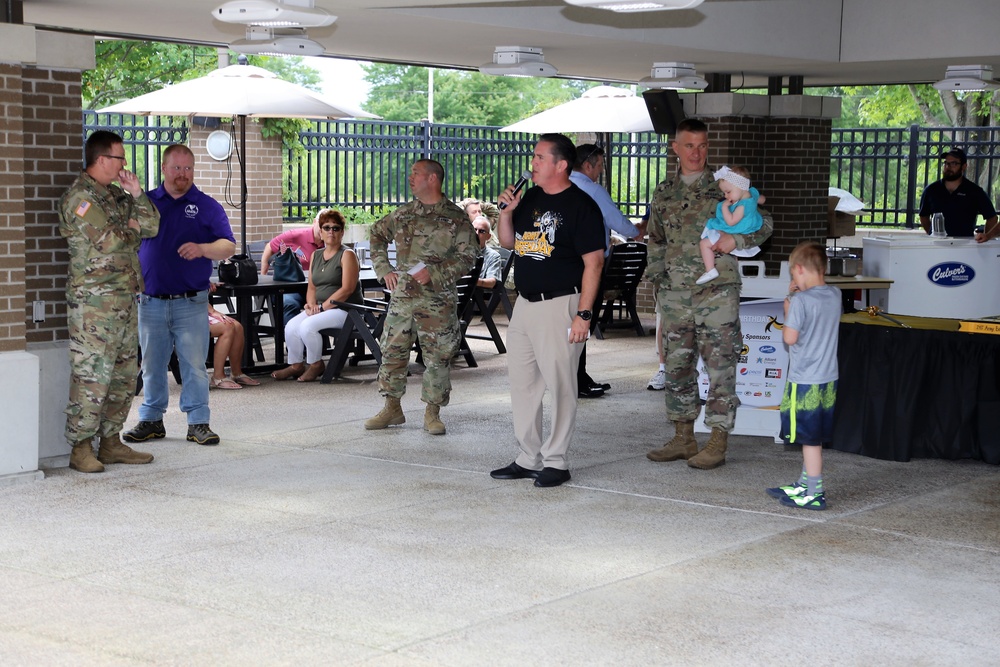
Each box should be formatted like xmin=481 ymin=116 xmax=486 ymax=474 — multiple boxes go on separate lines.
xmin=59 ymin=172 xmax=160 ymax=298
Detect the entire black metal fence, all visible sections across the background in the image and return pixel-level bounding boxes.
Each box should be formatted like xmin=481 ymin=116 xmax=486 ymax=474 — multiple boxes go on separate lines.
xmin=84 ymin=111 xmax=1000 ymax=227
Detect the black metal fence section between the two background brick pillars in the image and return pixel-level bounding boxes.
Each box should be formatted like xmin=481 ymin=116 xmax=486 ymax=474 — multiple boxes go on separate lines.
xmin=285 ymin=121 xmax=668 ymax=219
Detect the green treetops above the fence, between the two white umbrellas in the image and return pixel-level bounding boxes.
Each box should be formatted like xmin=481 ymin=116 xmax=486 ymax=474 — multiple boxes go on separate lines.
xmin=363 ymin=63 xmax=593 ymax=126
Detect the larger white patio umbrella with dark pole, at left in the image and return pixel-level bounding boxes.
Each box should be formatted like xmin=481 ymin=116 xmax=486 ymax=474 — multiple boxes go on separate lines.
xmin=98 ymin=64 xmax=377 ymax=253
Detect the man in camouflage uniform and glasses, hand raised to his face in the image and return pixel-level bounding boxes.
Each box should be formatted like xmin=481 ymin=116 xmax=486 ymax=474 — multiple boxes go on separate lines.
xmin=59 ymin=130 xmax=160 ymax=472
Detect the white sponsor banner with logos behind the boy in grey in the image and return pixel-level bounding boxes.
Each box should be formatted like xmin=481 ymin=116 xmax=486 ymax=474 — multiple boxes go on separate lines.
xmin=698 ymin=299 xmax=788 ymax=408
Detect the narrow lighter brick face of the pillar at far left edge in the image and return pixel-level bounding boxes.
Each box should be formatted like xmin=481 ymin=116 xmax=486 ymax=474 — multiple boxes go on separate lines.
xmin=0 ymin=63 xmax=25 ymax=352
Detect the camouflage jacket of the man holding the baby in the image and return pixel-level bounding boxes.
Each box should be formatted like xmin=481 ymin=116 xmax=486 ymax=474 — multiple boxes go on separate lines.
xmin=646 ymin=167 xmax=774 ymax=290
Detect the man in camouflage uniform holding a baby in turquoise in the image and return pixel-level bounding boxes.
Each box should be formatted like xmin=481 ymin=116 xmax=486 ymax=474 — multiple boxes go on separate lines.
xmin=646 ymin=119 xmax=773 ymax=470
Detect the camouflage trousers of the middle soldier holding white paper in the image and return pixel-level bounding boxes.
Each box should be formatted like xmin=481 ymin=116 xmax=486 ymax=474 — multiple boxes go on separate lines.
xmin=378 ymin=294 xmax=460 ymax=406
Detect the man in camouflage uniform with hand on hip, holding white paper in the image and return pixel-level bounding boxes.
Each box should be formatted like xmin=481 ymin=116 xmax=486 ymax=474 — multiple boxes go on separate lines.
xmin=365 ymin=160 xmax=479 ymax=435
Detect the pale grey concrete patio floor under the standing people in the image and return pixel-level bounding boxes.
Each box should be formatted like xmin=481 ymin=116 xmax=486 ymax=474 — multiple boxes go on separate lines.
xmin=0 ymin=320 xmax=1000 ymax=667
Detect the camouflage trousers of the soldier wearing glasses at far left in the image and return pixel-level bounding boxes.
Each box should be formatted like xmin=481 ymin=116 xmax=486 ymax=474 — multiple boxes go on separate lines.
xmin=66 ymin=294 xmax=139 ymax=444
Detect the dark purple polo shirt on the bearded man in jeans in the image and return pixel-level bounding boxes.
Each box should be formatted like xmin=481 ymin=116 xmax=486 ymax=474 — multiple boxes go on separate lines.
xmin=139 ymin=185 xmax=236 ymax=295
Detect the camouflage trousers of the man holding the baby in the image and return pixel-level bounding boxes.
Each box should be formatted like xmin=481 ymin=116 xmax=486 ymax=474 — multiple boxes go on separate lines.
xmin=656 ymin=285 xmax=743 ymax=431
